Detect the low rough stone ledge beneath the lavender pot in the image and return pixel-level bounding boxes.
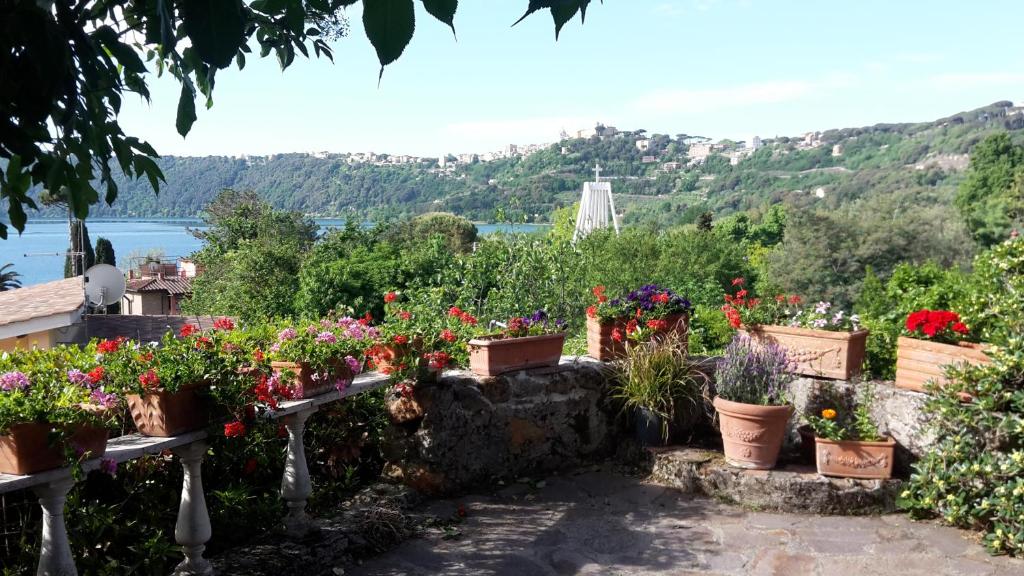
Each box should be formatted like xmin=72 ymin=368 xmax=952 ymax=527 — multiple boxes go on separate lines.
xmin=647 ymin=448 xmax=901 ymax=516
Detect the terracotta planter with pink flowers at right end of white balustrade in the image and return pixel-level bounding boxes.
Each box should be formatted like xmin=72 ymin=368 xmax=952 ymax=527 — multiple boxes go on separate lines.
xmin=268 ymin=317 xmax=368 ymax=400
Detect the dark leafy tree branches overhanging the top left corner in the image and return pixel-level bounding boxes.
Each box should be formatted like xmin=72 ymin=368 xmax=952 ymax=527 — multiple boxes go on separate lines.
xmin=0 ymin=0 xmax=591 ymax=238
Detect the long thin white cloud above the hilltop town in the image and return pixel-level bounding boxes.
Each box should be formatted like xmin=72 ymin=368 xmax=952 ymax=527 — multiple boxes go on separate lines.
xmin=632 ymin=73 xmax=857 ymax=114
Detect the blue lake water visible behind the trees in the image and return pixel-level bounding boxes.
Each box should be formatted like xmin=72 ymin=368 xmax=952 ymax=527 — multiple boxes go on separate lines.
xmin=0 ymin=219 xmax=547 ymax=286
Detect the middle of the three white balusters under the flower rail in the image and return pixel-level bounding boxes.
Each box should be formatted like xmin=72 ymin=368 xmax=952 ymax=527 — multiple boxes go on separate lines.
xmin=173 ymin=440 xmax=213 ymax=576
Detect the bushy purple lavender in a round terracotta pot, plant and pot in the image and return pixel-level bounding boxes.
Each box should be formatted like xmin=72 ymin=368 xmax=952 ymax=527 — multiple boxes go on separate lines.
xmin=714 ymin=334 xmax=793 ymax=469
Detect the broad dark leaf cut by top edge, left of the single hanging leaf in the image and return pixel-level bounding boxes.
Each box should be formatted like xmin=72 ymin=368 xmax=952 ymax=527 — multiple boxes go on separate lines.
xmin=182 ymin=0 xmax=246 ymax=68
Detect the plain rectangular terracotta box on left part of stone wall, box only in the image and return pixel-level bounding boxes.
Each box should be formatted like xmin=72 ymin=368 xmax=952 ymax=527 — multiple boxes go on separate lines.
xmin=469 ymin=333 xmax=565 ymax=376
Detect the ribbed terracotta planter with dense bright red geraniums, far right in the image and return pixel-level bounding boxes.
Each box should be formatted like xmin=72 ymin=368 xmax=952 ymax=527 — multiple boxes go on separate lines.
xmin=896 ymin=310 xmax=990 ymax=392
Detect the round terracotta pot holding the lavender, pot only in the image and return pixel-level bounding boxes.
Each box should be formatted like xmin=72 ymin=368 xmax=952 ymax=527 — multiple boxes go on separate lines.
xmin=714 ymin=397 xmax=793 ymax=470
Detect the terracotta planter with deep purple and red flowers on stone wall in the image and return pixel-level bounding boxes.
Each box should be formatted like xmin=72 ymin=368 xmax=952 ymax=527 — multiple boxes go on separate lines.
xmin=587 ymin=284 xmax=692 ymax=361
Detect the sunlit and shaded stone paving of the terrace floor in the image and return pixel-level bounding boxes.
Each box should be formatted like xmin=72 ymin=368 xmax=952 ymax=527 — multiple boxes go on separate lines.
xmin=350 ymin=468 xmax=1024 ymax=576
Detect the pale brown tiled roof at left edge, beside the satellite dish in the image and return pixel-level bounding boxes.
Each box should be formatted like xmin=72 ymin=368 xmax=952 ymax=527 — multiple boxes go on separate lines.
xmin=0 ymin=277 xmax=85 ymax=327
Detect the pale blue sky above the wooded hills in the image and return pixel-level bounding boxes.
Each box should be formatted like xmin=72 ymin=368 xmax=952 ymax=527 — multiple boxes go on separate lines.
xmin=121 ymin=0 xmax=1024 ymax=157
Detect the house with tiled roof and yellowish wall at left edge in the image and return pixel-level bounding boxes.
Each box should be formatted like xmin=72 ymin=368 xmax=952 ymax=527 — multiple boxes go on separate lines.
xmin=0 ymin=277 xmax=85 ymax=352
